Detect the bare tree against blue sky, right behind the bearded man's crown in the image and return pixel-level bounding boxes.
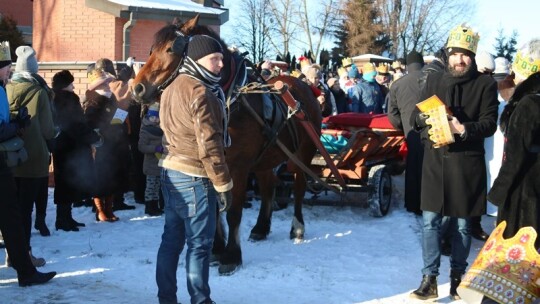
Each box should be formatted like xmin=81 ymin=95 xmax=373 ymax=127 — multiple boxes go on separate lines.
xmin=376 ymin=0 xmax=473 ymax=57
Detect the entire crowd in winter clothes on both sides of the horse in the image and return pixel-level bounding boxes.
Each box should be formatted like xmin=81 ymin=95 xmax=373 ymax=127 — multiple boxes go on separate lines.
xmin=0 ymin=25 xmax=540 ymax=303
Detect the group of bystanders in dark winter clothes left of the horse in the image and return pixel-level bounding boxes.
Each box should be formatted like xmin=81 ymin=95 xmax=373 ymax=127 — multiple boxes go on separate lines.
xmin=0 ymin=42 xmax=163 ymax=286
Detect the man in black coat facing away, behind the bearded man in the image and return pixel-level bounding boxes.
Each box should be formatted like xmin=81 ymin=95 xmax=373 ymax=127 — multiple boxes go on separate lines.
xmin=388 ymin=51 xmax=424 ymax=215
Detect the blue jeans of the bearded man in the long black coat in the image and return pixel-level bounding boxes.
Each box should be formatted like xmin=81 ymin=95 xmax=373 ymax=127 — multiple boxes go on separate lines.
xmin=422 ymin=211 xmax=471 ymax=276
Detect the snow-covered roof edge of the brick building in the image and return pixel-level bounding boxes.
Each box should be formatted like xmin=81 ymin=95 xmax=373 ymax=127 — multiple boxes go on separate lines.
xmin=107 ymin=0 xmax=223 ymax=15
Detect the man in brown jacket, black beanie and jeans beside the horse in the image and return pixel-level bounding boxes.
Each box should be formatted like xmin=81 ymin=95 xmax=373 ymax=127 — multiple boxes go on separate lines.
xmin=156 ymin=35 xmax=233 ymax=304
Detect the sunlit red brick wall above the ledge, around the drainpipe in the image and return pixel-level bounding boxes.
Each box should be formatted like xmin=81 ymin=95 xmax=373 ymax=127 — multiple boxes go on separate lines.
xmin=31 ymin=0 xmax=166 ymax=62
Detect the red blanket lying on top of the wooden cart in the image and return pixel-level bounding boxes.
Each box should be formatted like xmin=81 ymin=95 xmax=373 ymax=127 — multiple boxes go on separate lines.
xmin=323 ymin=113 xmax=394 ymax=129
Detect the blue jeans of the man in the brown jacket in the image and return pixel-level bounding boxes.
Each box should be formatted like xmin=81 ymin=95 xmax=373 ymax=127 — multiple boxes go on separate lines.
xmin=156 ymin=169 xmax=217 ymax=304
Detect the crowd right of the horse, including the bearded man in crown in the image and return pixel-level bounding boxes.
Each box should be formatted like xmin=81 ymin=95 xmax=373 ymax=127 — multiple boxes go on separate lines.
xmin=262 ymin=24 xmax=540 ymax=303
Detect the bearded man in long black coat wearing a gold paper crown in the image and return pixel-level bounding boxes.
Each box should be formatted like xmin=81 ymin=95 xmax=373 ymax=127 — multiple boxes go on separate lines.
xmin=411 ymin=25 xmax=499 ymax=300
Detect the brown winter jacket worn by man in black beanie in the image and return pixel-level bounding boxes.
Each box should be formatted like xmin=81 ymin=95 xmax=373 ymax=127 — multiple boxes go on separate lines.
xmin=159 ymin=75 xmax=233 ymax=192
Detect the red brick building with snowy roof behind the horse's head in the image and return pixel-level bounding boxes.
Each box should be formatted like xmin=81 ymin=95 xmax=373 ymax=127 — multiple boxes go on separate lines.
xmin=0 ymin=0 xmax=229 ymax=94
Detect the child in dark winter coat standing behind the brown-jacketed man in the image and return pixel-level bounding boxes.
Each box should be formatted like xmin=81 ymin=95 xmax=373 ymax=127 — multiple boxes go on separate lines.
xmin=139 ymin=103 xmax=163 ymax=216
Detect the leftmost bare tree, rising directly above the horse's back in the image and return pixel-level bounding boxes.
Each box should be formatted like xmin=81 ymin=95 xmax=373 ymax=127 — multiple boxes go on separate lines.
xmin=234 ymin=0 xmax=270 ymax=63
